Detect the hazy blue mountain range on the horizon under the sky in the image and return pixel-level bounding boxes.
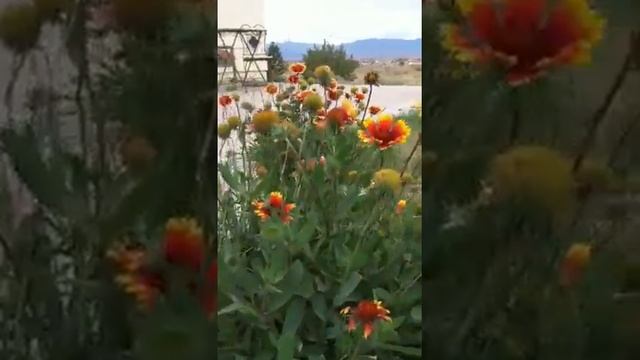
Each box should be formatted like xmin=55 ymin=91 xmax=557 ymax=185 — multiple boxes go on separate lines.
xmin=277 ymin=39 xmax=422 ymax=61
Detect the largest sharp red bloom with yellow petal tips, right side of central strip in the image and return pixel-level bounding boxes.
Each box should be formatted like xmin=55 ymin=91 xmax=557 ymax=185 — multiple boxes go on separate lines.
xmin=358 ymin=113 xmax=411 ymax=150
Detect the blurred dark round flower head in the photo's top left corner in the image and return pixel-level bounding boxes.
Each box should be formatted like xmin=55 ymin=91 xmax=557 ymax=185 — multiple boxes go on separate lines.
xmin=0 ymin=3 xmax=42 ymax=53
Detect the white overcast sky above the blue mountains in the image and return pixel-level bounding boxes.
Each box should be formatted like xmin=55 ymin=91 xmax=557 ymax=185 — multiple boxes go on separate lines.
xmin=264 ymin=0 xmax=422 ymax=44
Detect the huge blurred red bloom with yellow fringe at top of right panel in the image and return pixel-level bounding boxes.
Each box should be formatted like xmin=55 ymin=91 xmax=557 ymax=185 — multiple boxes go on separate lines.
xmin=442 ymin=0 xmax=605 ymax=86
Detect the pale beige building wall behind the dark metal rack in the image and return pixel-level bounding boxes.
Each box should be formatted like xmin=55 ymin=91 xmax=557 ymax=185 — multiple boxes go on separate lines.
xmin=218 ymin=0 xmax=268 ymax=82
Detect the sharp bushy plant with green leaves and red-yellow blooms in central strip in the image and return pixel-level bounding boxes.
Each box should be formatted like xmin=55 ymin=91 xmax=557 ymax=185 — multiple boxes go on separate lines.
xmin=218 ymin=63 xmax=421 ymax=358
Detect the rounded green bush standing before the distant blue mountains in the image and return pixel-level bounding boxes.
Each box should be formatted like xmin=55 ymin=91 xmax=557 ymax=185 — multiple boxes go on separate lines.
xmin=303 ymin=41 xmax=360 ymax=80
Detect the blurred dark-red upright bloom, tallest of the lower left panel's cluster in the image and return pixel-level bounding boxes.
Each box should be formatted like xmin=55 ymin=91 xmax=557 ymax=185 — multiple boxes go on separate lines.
xmin=163 ymin=218 xmax=204 ymax=271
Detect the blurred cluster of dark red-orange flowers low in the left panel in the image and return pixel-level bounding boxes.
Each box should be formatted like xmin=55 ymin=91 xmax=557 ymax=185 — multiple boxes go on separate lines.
xmin=107 ymin=218 xmax=218 ymax=316
